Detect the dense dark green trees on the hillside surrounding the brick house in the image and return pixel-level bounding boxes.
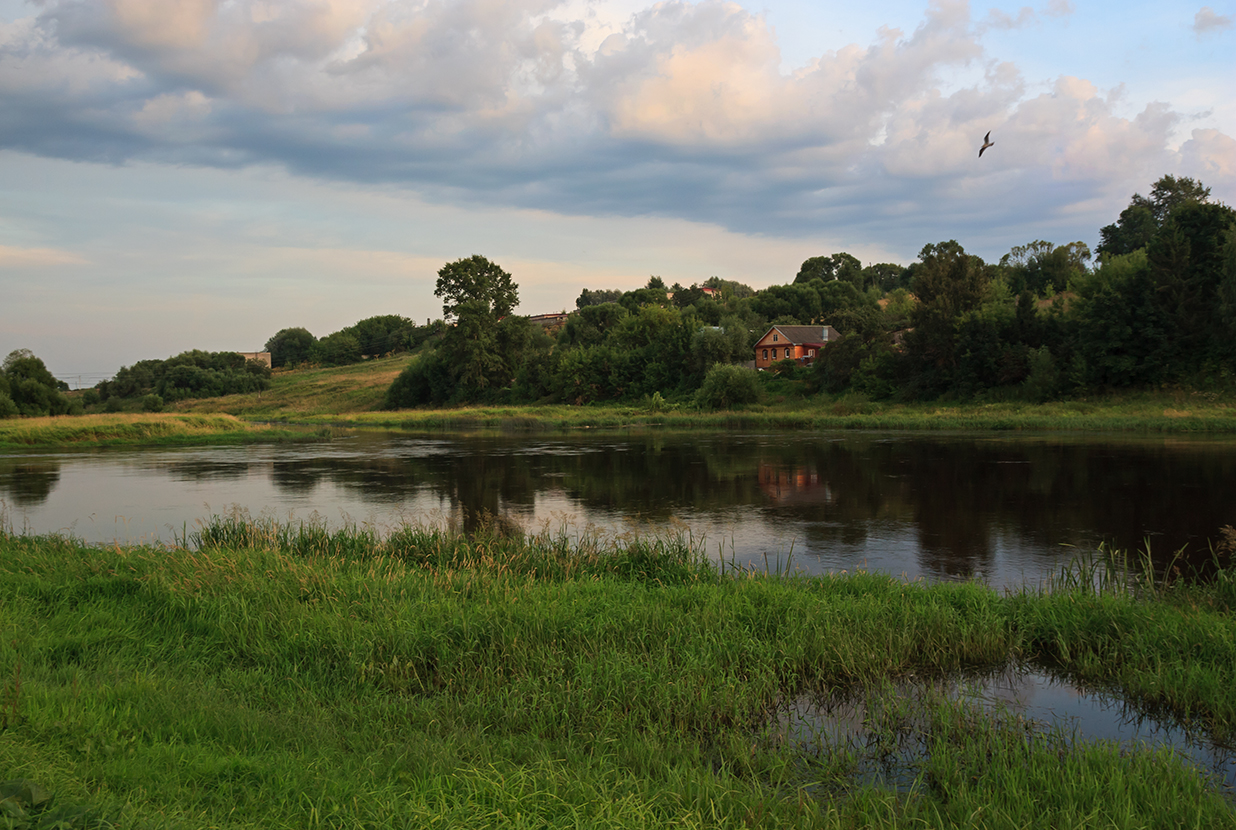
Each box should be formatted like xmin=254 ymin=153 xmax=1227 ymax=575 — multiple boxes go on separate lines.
xmin=387 ymin=177 xmax=1236 ymax=408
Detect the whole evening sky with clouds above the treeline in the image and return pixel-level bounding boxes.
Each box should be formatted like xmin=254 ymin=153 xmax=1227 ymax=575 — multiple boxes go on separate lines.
xmin=0 ymin=0 xmax=1236 ymax=387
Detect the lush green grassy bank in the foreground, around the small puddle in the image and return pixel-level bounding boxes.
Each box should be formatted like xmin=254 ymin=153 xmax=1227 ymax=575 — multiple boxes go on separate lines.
xmin=0 ymin=518 xmax=1236 ymax=828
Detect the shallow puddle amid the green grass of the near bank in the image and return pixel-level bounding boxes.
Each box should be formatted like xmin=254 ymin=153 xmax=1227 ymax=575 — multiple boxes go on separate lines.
xmin=768 ymin=667 xmax=1236 ymax=795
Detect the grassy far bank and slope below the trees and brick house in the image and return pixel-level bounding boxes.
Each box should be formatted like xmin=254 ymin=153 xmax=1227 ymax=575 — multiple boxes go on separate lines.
xmin=156 ymin=357 xmax=1236 ymax=434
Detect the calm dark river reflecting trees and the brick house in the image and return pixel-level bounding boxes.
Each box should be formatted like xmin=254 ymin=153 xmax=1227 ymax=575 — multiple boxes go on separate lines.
xmin=0 ymin=432 xmax=1236 ymax=587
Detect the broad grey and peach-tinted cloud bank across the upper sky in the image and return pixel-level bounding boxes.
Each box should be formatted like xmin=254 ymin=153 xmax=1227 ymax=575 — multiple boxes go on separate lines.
xmin=0 ymin=0 xmax=1232 ymax=247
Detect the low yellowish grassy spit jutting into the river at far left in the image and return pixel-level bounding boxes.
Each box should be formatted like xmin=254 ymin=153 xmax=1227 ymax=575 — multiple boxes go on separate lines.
xmin=0 ymin=413 xmax=316 ymax=448
